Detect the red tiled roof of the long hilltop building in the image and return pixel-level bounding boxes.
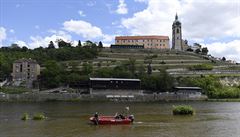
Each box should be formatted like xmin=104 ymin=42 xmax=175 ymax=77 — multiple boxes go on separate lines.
xmin=115 ymin=35 xmax=169 ymax=40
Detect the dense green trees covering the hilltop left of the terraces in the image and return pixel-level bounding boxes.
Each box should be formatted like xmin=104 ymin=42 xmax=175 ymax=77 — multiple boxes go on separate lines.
xmin=0 ymin=40 xmax=101 ymax=78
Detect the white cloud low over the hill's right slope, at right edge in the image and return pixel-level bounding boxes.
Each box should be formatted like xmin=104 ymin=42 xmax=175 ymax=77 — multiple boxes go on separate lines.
xmin=202 ymin=40 xmax=240 ymax=62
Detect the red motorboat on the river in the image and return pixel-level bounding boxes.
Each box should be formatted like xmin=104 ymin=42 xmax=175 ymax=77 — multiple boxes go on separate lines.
xmin=90 ymin=115 xmax=134 ymax=125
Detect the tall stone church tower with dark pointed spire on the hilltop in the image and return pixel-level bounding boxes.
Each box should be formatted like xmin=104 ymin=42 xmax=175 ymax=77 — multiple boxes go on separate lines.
xmin=172 ymin=14 xmax=183 ymax=50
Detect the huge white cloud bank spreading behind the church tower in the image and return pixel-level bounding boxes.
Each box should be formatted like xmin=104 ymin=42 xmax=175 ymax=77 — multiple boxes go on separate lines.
xmin=122 ymin=0 xmax=240 ymax=40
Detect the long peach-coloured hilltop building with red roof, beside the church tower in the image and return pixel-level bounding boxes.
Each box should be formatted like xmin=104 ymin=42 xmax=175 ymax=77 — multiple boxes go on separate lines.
xmin=112 ymin=35 xmax=170 ymax=49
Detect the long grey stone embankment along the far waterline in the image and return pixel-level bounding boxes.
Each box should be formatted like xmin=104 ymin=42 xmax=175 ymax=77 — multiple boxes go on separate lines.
xmin=0 ymin=92 xmax=207 ymax=102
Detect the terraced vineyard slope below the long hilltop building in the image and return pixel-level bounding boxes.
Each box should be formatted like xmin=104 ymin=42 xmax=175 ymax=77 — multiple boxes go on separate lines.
xmin=62 ymin=48 xmax=240 ymax=75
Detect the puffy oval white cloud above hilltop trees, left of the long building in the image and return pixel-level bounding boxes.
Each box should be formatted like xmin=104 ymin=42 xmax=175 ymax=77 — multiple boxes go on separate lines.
xmin=63 ymin=20 xmax=103 ymax=39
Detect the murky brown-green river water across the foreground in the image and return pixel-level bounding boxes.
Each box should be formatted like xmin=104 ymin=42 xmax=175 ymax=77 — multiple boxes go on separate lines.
xmin=0 ymin=102 xmax=240 ymax=137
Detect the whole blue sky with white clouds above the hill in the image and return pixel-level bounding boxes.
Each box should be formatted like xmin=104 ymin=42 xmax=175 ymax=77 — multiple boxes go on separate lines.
xmin=0 ymin=0 xmax=240 ymax=62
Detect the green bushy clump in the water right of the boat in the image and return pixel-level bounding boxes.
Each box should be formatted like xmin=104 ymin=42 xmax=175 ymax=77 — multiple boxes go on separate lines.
xmin=173 ymin=105 xmax=194 ymax=115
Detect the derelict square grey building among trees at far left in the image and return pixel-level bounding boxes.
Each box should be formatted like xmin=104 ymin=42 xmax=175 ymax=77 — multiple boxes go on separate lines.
xmin=12 ymin=58 xmax=40 ymax=88
